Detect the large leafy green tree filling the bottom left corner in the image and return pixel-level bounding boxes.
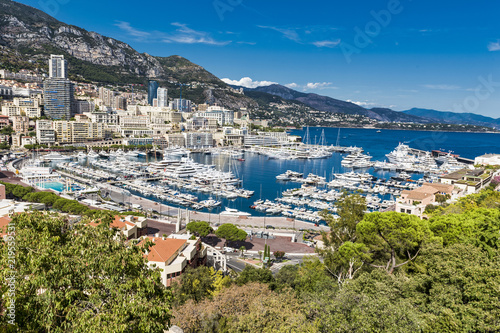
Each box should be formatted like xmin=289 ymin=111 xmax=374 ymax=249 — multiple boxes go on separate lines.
xmin=0 ymin=212 xmax=171 ymax=332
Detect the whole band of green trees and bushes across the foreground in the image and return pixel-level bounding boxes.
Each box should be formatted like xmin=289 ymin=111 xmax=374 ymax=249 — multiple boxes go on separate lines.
xmin=0 ymin=183 xmax=500 ymax=332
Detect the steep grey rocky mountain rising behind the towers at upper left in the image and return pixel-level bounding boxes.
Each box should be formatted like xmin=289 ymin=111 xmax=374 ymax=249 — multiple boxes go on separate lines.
xmin=0 ymin=0 xmax=227 ymax=87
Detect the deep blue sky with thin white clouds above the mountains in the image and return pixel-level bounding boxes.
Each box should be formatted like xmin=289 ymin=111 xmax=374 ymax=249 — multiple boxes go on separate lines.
xmin=13 ymin=0 xmax=500 ymax=118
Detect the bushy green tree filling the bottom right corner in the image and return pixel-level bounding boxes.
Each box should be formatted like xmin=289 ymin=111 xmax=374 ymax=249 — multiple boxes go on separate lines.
xmin=408 ymin=244 xmax=500 ymax=332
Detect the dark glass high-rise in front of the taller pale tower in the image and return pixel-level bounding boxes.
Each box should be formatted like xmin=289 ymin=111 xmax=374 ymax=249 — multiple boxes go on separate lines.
xmin=43 ymin=78 xmax=74 ymax=119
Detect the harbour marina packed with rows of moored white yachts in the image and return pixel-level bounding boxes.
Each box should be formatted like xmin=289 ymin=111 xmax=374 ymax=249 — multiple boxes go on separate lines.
xmin=14 ymin=129 xmax=500 ymax=224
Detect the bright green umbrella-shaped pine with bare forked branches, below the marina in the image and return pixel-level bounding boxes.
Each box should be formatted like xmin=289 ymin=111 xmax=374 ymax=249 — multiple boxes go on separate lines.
xmin=356 ymin=212 xmax=432 ymax=274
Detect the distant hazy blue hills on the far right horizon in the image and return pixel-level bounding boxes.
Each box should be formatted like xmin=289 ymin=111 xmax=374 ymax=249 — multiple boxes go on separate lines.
xmin=402 ymin=108 xmax=500 ymax=129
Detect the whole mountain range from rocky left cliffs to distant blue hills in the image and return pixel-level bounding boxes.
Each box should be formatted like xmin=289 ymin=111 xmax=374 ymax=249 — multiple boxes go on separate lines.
xmin=0 ymin=0 xmax=500 ymax=127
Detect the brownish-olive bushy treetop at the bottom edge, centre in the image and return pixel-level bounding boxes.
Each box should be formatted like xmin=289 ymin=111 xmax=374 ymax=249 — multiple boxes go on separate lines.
xmin=173 ymin=283 xmax=315 ymax=333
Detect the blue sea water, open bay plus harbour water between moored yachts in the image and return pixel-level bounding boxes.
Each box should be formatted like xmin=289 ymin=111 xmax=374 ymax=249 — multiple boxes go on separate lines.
xmin=72 ymin=127 xmax=500 ymax=216
